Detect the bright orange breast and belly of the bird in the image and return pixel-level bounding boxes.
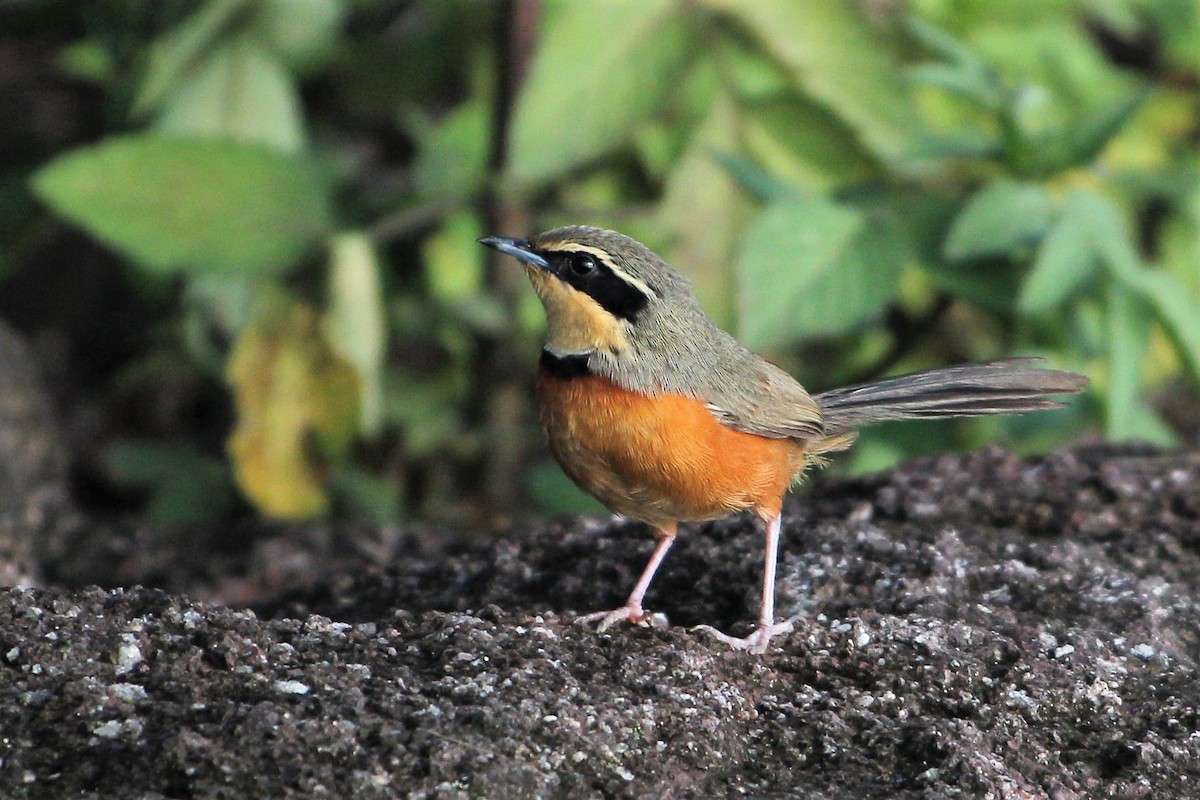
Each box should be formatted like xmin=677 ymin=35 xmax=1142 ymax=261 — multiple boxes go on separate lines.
xmin=538 ymin=373 xmax=804 ymax=524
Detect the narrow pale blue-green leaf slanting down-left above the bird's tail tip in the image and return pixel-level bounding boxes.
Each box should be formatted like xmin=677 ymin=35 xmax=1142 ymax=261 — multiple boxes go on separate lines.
xmin=1018 ymin=192 xmax=1098 ymax=314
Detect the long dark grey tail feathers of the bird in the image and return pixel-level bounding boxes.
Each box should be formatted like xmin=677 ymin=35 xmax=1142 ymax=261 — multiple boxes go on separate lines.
xmin=814 ymin=359 xmax=1087 ymax=434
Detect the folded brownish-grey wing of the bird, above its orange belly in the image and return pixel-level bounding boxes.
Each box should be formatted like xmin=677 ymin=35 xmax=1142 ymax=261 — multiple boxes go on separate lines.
xmin=708 ymin=354 xmax=824 ymax=439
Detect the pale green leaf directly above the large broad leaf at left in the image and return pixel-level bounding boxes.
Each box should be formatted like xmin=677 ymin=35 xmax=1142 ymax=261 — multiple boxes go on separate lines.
xmin=156 ymin=36 xmax=305 ymax=154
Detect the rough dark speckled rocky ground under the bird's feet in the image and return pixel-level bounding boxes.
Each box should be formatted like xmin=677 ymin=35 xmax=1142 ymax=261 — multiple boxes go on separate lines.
xmin=0 ymin=321 xmax=1200 ymax=800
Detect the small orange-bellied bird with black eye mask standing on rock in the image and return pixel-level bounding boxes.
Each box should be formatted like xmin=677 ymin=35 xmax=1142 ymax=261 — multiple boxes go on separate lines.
xmin=478 ymin=225 xmax=1087 ymax=652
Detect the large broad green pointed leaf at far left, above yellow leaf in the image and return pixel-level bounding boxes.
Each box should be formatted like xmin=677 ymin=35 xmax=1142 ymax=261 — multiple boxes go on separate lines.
xmin=34 ymin=136 xmax=329 ymax=272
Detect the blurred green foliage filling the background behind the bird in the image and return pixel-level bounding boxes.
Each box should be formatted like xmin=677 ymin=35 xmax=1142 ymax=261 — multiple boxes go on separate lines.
xmin=0 ymin=0 xmax=1200 ymax=525
